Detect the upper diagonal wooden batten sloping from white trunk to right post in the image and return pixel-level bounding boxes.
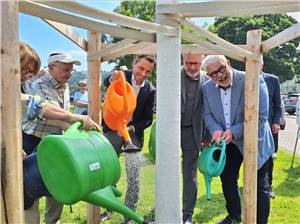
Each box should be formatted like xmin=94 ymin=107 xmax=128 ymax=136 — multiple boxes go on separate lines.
xmin=181 ymin=18 xmax=256 ymax=58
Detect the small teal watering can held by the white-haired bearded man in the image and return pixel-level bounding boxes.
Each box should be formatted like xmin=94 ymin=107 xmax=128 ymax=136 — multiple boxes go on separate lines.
xmin=198 ymin=139 xmax=226 ymax=200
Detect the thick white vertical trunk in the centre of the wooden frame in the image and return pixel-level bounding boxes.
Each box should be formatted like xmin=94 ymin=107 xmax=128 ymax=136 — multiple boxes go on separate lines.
xmin=155 ymin=0 xmax=182 ymax=223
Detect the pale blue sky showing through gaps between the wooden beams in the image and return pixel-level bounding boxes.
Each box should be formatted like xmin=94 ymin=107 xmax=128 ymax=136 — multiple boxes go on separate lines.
xmin=19 ymin=0 xmax=300 ymax=71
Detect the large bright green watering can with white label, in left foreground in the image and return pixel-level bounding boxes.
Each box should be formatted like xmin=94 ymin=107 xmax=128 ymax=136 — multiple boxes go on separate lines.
xmin=37 ymin=122 xmax=146 ymax=223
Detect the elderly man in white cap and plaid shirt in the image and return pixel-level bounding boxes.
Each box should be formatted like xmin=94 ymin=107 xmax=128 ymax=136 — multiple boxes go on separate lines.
xmin=23 ymin=52 xmax=81 ymax=224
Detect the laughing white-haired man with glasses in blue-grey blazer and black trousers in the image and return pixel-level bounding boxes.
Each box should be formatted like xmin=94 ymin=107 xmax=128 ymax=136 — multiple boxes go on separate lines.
xmin=202 ymin=55 xmax=274 ymax=224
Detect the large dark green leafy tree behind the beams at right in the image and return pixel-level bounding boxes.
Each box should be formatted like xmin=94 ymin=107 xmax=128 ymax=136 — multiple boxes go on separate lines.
xmin=209 ymin=14 xmax=300 ymax=82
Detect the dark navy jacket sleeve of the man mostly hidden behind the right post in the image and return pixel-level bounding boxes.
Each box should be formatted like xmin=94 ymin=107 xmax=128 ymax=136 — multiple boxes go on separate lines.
xmin=269 ymin=77 xmax=283 ymax=125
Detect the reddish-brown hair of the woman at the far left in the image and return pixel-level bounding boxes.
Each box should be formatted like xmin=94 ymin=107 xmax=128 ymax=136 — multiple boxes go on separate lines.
xmin=20 ymin=42 xmax=41 ymax=75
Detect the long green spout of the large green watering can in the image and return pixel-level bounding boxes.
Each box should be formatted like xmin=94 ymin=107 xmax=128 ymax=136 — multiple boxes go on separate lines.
xmin=83 ymin=186 xmax=146 ymax=224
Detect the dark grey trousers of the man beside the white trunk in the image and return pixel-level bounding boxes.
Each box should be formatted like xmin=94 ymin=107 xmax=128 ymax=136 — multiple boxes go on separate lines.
xmin=181 ymin=127 xmax=199 ymax=221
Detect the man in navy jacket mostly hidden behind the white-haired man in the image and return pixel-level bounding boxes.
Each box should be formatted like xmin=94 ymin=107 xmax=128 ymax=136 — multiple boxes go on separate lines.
xmin=261 ymin=57 xmax=284 ymax=198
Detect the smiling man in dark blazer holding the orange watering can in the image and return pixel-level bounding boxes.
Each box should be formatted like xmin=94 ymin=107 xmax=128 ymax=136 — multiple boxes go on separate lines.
xmin=103 ymin=55 xmax=155 ymax=223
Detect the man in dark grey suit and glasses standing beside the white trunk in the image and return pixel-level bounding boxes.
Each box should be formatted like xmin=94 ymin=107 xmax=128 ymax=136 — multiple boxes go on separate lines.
xmin=181 ymin=54 xmax=207 ymax=224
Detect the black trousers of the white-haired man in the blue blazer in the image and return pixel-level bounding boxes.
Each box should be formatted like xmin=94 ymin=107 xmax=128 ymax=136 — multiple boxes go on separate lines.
xmin=221 ymin=143 xmax=270 ymax=224
